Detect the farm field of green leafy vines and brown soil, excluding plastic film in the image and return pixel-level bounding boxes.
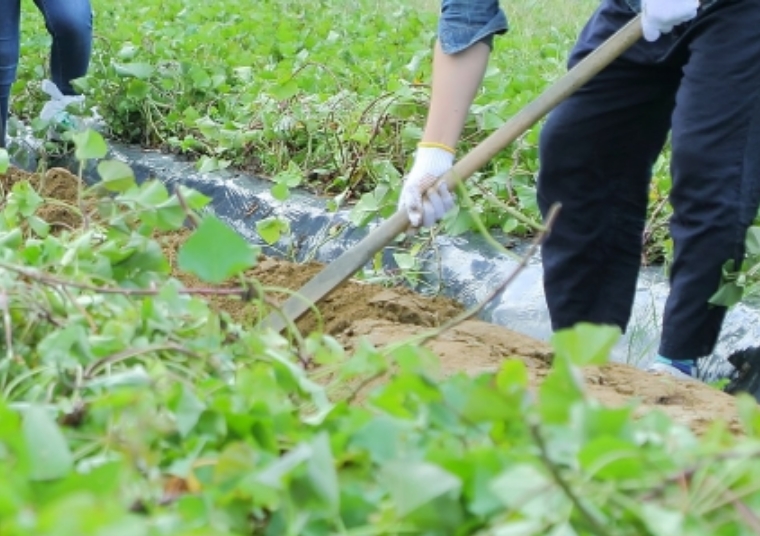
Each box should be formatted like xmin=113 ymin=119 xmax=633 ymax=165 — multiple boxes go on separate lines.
xmin=0 ymin=0 xmax=760 ymax=536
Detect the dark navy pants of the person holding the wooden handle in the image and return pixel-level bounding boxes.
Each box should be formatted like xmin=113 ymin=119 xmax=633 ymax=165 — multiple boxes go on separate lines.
xmin=538 ymin=0 xmax=760 ymax=359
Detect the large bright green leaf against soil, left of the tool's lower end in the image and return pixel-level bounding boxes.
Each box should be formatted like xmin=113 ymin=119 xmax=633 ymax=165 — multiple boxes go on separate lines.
xmin=177 ymin=215 xmax=256 ymax=283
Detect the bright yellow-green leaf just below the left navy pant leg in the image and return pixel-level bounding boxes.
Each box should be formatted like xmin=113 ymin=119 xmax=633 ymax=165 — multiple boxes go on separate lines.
xmin=552 ymin=323 xmax=620 ymax=366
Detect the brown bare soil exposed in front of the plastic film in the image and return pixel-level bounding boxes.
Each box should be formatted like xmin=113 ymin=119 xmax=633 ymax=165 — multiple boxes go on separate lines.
xmin=0 ymin=170 xmax=739 ymax=433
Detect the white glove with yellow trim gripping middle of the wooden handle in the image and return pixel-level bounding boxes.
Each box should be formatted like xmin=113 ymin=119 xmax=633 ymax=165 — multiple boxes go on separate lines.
xmin=398 ymin=147 xmax=454 ymax=227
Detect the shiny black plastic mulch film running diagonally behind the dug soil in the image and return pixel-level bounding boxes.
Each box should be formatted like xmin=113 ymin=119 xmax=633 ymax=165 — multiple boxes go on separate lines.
xmin=5 ymin=135 xmax=760 ymax=401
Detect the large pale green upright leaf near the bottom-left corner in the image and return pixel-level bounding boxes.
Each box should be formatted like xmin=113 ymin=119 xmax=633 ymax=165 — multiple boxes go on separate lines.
xmin=22 ymin=405 xmax=74 ymax=480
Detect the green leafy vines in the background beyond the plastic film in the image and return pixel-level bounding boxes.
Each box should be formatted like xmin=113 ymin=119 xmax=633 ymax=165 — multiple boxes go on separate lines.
xmin=14 ymin=0 xmax=612 ymax=260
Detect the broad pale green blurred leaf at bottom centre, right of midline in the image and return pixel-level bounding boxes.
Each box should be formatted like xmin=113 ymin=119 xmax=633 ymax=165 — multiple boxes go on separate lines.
xmin=380 ymin=461 xmax=462 ymax=516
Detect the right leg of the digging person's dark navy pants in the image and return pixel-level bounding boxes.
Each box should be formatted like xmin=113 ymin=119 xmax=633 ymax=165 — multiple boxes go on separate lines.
xmin=660 ymin=2 xmax=760 ymax=366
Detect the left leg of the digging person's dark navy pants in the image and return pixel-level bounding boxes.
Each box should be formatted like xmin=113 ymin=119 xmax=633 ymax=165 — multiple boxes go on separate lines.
xmin=538 ymin=0 xmax=680 ymax=331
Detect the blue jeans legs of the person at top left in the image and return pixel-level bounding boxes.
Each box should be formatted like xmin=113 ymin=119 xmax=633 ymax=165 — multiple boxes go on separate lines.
xmin=0 ymin=0 xmax=93 ymax=147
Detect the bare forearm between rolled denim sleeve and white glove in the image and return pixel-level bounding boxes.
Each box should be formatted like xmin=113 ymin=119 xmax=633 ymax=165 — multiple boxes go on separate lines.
xmin=422 ymin=42 xmax=491 ymax=148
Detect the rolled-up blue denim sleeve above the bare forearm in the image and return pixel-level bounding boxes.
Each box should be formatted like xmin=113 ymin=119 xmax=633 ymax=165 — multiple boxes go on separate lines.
xmin=438 ymin=0 xmax=508 ymax=54
